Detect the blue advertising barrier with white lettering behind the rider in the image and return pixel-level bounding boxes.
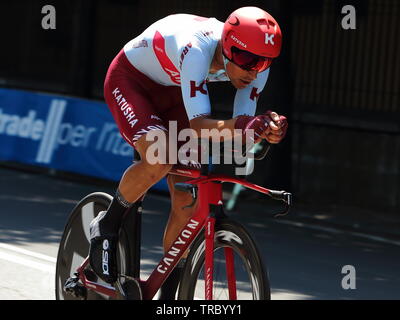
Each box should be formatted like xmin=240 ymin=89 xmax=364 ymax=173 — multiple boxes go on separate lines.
xmin=0 ymin=88 xmax=168 ymax=190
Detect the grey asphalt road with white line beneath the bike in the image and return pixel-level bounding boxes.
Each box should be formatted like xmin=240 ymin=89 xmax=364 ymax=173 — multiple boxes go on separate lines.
xmin=0 ymin=168 xmax=400 ymax=300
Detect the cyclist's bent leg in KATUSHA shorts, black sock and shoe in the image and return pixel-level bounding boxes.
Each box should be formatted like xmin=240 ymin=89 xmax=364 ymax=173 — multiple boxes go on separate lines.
xmin=89 ymin=51 xmax=171 ymax=283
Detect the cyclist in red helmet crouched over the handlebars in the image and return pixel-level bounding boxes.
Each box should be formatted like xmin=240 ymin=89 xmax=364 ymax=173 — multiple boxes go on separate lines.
xmin=89 ymin=7 xmax=287 ymax=299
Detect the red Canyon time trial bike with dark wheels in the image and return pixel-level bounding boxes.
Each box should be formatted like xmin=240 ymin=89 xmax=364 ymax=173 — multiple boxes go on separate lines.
xmin=55 ymin=142 xmax=292 ymax=300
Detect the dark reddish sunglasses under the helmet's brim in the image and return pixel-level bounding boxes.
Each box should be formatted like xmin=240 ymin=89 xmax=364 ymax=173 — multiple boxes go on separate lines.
xmin=229 ymin=47 xmax=273 ymax=72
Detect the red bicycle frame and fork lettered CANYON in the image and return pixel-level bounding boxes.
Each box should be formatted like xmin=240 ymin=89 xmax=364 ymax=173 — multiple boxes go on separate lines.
xmin=77 ymin=168 xmax=290 ymax=300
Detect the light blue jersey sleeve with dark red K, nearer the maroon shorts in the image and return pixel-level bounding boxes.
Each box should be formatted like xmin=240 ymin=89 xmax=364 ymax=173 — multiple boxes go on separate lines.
xmin=181 ymin=46 xmax=211 ymax=120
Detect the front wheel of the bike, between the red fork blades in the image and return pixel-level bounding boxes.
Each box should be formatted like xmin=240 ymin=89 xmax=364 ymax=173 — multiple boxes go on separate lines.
xmin=178 ymin=219 xmax=271 ymax=300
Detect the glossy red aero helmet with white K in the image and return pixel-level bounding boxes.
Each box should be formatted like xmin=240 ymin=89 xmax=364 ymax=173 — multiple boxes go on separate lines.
xmin=221 ymin=7 xmax=282 ymax=60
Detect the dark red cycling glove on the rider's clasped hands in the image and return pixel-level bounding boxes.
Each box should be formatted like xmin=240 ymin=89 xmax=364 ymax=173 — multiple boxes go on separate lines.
xmin=235 ymin=114 xmax=273 ymax=143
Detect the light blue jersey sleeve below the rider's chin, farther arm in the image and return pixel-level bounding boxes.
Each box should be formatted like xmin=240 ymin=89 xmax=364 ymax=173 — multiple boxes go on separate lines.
xmin=232 ymin=69 xmax=269 ymax=118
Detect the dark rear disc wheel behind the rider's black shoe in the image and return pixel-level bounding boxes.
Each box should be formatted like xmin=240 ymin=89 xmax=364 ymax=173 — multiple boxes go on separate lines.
xmin=55 ymin=192 xmax=131 ymax=300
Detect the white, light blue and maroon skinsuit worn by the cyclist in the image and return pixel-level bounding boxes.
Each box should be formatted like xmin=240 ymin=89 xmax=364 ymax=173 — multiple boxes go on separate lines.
xmin=104 ymin=14 xmax=269 ymax=145
